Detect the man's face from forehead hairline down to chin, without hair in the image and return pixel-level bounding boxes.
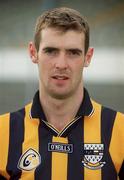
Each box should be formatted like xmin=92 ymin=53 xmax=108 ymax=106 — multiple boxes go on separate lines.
xmin=30 ymin=28 xmax=93 ymax=99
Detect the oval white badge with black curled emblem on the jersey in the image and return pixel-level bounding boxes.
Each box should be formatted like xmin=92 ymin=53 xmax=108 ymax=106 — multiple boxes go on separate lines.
xmin=18 ymin=148 xmax=41 ymax=171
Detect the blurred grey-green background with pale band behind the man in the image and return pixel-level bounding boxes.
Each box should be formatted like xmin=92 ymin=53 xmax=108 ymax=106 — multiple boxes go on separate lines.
xmin=0 ymin=0 xmax=124 ymax=114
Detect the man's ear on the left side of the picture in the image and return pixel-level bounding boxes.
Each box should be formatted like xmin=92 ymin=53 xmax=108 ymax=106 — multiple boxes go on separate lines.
xmin=28 ymin=42 xmax=38 ymax=63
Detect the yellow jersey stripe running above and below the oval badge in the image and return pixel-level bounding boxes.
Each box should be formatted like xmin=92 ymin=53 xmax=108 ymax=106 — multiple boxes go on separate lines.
xmin=21 ymin=105 xmax=39 ymax=180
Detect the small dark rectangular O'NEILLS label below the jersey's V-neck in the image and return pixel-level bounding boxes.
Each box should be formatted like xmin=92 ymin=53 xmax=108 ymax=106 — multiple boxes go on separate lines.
xmin=48 ymin=142 xmax=73 ymax=153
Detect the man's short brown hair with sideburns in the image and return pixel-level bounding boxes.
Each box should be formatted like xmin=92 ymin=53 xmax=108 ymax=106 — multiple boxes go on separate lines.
xmin=34 ymin=7 xmax=89 ymax=54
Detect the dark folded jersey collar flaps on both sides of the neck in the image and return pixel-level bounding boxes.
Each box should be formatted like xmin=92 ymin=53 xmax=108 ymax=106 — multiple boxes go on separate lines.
xmin=30 ymin=88 xmax=94 ymax=121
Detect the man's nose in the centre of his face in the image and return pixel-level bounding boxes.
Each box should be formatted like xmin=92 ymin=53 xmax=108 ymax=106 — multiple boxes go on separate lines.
xmin=55 ymin=53 xmax=68 ymax=69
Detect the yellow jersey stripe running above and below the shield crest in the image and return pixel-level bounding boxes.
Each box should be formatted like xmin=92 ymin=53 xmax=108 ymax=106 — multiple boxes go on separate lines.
xmin=84 ymin=102 xmax=101 ymax=180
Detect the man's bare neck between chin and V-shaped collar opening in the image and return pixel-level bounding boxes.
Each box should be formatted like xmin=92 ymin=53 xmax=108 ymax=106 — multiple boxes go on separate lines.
xmin=40 ymin=86 xmax=83 ymax=131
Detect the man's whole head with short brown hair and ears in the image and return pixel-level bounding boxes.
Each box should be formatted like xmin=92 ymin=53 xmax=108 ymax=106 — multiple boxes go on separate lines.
xmin=29 ymin=8 xmax=93 ymax=99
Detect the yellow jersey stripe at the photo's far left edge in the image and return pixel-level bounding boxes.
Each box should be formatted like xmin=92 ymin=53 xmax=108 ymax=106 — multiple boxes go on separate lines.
xmin=0 ymin=114 xmax=10 ymax=179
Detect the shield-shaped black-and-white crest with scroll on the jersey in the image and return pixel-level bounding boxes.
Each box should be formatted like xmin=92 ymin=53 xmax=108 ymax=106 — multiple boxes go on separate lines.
xmin=82 ymin=144 xmax=105 ymax=170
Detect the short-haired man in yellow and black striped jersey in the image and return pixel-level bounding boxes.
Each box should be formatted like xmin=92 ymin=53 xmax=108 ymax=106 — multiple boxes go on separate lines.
xmin=0 ymin=8 xmax=124 ymax=180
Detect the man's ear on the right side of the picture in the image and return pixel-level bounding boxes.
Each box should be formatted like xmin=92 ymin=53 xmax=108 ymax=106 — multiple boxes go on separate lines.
xmin=84 ymin=48 xmax=94 ymax=67
